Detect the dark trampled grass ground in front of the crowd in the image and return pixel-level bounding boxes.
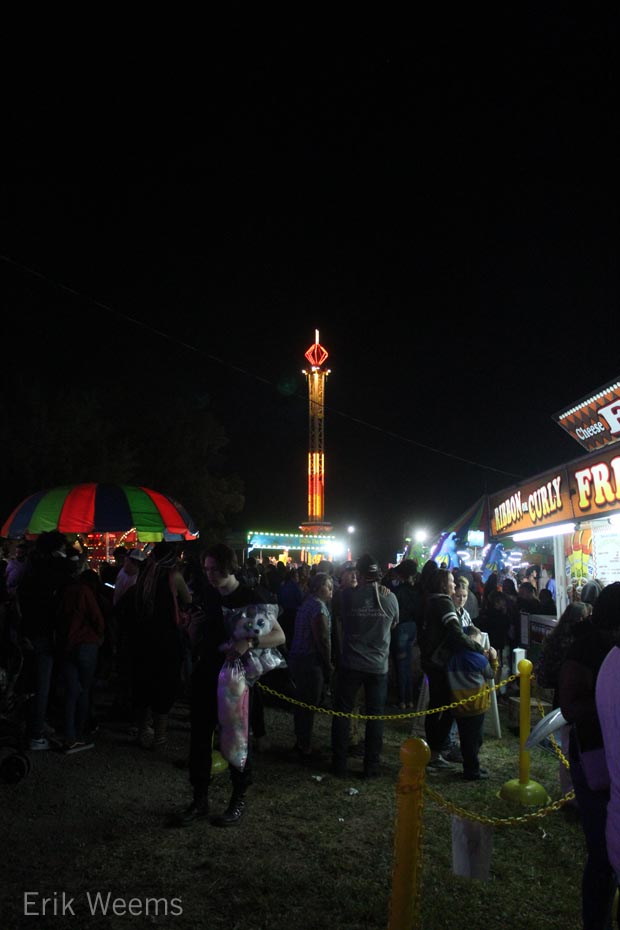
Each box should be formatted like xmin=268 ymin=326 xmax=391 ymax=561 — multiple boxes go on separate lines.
xmin=0 ymin=676 xmax=584 ymax=930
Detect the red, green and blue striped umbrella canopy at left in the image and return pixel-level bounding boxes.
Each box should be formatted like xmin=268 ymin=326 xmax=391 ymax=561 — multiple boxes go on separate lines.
xmin=0 ymin=484 xmax=199 ymax=542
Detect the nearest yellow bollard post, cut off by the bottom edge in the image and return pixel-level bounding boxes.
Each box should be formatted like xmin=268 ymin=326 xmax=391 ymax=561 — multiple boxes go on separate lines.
xmin=388 ymin=738 xmax=431 ymax=930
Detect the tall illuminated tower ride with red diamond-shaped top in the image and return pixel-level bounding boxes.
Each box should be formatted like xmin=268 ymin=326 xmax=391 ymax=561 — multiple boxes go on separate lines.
xmin=300 ymin=329 xmax=332 ymax=533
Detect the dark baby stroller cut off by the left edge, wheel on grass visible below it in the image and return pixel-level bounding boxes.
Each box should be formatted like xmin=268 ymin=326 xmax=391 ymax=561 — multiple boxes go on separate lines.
xmin=0 ymin=605 xmax=30 ymax=785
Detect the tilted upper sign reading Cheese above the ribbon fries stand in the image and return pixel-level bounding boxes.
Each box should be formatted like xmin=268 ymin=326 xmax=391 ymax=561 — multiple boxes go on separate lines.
xmin=553 ymin=380 xmax=620 ymax=451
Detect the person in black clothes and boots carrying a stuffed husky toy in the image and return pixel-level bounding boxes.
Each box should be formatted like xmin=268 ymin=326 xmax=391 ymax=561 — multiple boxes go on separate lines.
xmin=175 ymin=543 xmax=285 ymax=827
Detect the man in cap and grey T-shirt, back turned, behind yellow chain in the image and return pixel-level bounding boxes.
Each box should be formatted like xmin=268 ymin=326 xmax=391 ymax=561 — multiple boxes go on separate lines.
xmin=332 ymin=554 xmax=398 ymax=778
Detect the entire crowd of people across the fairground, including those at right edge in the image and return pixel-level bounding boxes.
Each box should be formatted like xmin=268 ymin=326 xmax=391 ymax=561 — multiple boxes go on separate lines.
xmin=0 ymin=531 xmax=620 ymax=930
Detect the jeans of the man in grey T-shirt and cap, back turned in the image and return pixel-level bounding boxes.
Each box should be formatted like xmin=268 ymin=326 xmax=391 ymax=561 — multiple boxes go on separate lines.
xmin=332 ymin=668 xmax=388 ymax=773
